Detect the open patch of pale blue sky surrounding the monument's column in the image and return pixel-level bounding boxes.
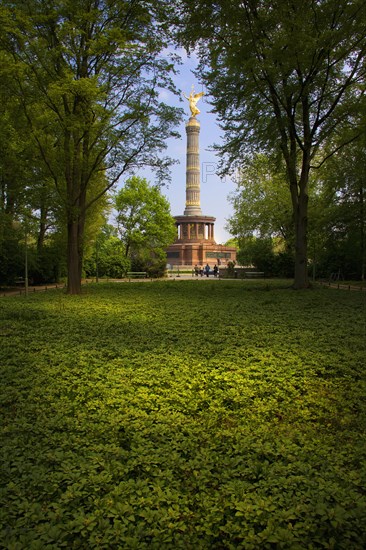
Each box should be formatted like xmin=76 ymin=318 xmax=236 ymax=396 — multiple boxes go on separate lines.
xmin=141 ymin=52 xmax=236 ymax=244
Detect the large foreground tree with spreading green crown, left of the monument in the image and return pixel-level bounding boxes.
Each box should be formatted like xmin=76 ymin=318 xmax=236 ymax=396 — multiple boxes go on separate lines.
xmin=0 ymin=0 xmax=182 ymax=294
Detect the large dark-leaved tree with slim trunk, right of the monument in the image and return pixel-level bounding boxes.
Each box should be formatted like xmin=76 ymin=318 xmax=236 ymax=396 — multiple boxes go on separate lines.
xmin=175 ymin=0 xmax=366 ymax=288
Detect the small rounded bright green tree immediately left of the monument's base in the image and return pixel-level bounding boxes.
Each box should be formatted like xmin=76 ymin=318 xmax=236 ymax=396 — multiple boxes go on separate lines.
xmin=115 ymin=176 xmax=176 ymax=274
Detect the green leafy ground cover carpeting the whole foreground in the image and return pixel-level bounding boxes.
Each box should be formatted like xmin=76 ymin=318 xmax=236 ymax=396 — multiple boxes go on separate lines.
xmin=0 ymin=280 xmax=366 ymax=550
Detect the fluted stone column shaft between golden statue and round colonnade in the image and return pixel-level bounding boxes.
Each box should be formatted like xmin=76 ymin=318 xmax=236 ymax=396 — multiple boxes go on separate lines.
xmin=184 ymin=117 xmax=202 ymax=216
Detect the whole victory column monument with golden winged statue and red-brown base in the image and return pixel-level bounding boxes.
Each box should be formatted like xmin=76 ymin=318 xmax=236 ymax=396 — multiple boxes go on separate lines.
xmin=167 ymin=86 xmax=236 ymax=269
